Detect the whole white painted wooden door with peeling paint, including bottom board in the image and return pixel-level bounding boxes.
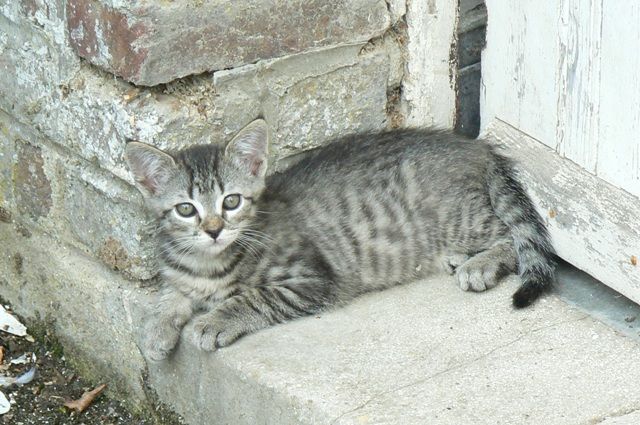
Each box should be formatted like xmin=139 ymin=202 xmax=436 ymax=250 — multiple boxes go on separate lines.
xmin=481 ymin=0 xmax=640 ymax=302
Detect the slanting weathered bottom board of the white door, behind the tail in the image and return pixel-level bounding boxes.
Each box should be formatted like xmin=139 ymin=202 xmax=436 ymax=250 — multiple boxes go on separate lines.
xmin=485 ymin=120 xmax=640 ymax=303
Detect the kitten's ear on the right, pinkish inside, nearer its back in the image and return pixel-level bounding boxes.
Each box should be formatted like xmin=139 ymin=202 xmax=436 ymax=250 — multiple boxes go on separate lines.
xmin=224 ymin=119 xmax=269 ymax=177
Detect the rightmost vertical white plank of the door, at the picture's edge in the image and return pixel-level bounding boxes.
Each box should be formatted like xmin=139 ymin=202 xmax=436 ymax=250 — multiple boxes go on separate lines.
xmin=597 ymin=4 xmax=640 ymax=197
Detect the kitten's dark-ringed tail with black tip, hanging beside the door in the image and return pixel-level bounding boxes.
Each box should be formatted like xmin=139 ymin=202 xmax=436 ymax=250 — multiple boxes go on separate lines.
xmin=487 ymin=152 xmax=555 ymax=308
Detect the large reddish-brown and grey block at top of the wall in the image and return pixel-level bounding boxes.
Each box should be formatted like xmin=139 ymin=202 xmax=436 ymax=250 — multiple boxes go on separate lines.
xmin=66 ymin=0 xmax=397 ymax=86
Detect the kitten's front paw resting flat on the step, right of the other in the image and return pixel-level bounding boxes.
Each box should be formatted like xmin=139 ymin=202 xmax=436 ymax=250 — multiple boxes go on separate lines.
xmin=185 ymin=313 xmax=242 ymax=351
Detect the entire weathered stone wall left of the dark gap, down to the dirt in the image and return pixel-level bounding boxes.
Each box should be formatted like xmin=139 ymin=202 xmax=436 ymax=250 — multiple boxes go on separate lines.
xmin=0 ymin=0 xmax=456 ymax=418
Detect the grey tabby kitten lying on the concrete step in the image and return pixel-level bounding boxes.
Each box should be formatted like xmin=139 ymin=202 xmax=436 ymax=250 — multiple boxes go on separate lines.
xmin=126 ymin=120 xmax=554 ymax=360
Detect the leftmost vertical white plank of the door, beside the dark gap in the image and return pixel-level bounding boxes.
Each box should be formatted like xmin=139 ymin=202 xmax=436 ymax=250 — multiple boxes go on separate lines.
xmin=481 ymin=0 xmax=559 ymax=147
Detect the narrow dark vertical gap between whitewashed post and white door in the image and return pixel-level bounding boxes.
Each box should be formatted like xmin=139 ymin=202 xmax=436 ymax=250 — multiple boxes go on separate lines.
xmin=455 ymin=0 xmax=487 ymax=137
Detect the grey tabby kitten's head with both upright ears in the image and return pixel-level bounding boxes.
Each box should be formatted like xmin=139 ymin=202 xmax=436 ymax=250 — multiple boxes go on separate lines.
xmin=126 ymin=120 xmax=269 ymax=255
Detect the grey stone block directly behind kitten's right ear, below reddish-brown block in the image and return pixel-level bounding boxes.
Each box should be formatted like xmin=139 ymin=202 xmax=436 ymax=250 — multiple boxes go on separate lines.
xmin=213 ymin=45 xmax=395 ymax=158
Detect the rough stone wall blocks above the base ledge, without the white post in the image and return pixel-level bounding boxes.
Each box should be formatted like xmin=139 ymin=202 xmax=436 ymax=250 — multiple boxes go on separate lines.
xmin=0 ymin=0 xmax=404 ymax=279
